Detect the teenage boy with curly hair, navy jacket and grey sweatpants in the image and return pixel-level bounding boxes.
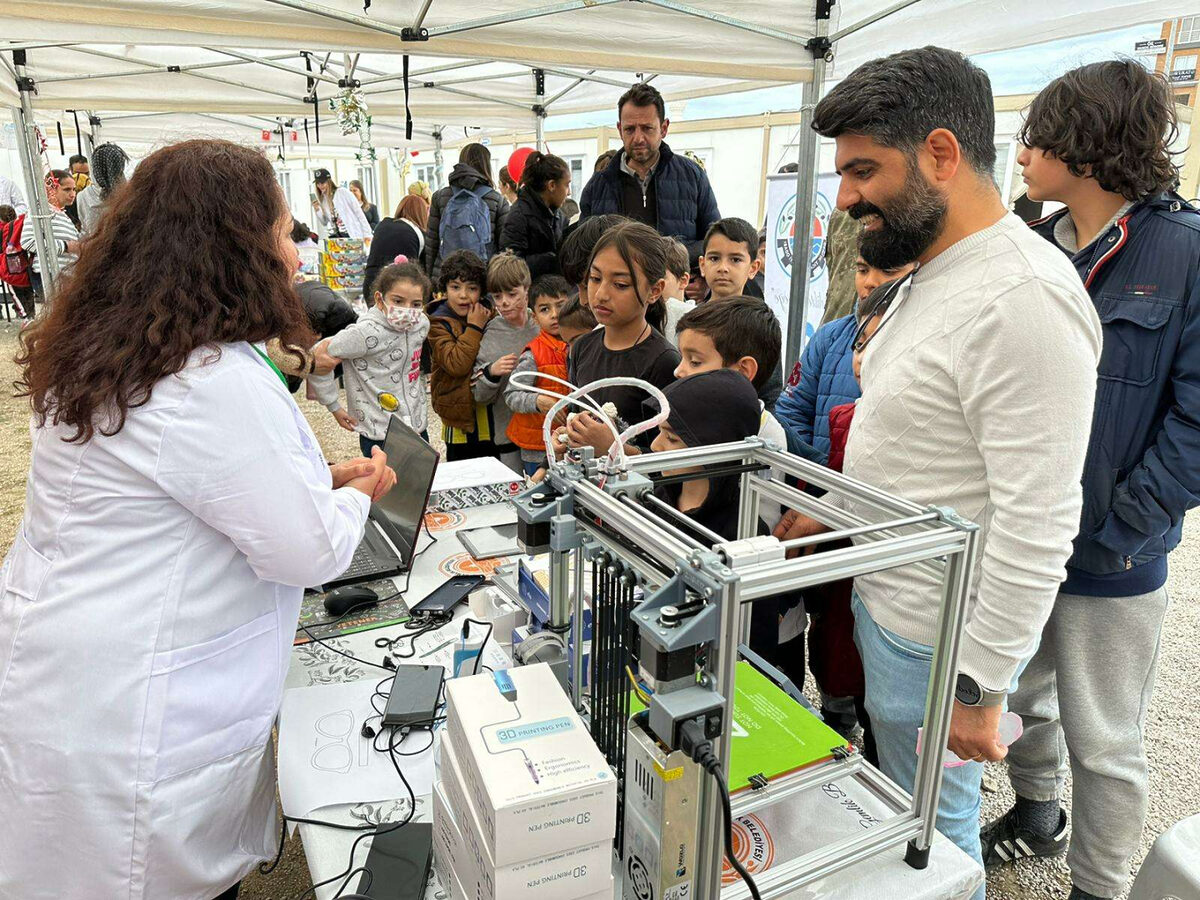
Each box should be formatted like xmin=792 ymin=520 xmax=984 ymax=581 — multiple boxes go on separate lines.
xmin=982 ymin=60 xmax=1200 ymax=900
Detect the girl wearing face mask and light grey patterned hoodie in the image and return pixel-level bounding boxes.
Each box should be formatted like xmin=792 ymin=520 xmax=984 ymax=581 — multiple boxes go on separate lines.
xmin=308 ymin=257 xmax=430 ymax=457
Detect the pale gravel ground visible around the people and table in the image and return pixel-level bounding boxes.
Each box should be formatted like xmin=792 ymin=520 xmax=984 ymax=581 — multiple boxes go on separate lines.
xmin=0 ymin=323 xmax=1200 ymax=900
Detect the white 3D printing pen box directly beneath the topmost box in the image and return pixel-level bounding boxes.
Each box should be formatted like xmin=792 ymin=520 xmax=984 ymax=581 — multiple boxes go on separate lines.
xmin=433 ymin=761 xmax=612 ymax=900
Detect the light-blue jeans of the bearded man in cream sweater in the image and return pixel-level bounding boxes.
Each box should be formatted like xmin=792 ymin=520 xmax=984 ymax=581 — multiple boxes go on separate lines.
xmin=851 ymin=593 xmax=1025 ymax=900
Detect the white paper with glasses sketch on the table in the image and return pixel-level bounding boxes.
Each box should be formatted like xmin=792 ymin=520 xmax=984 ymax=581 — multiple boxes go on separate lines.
xmin=278 ymin=681 xmax=436 ymax=817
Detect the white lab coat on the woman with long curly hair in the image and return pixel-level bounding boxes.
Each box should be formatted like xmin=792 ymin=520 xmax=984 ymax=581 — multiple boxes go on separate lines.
xmin=0 ymin=343 xmax=370 ymax=900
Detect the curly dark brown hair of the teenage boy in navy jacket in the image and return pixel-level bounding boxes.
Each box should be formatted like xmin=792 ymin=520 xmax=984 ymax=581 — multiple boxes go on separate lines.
xmin=1016 ymin=60 xmax=1180 ymax=200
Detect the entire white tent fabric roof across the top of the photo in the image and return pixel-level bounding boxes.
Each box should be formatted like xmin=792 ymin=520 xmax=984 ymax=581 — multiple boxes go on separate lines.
xmin=0 ymin=0 xmax=1194 ymax=153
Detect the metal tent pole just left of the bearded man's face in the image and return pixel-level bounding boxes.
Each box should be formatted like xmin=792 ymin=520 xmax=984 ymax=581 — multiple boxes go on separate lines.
xmin=785 ymin=6 xmax=833 ymax=368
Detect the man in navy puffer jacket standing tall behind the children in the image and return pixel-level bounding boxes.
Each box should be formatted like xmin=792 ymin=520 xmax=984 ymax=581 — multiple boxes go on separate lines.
xmin=580 ymin=84 xmax=721 ymax=260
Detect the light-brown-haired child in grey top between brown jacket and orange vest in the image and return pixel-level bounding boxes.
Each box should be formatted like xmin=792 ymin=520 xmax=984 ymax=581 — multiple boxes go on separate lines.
xmin=470 ymin=253 xmax=541 ymax=472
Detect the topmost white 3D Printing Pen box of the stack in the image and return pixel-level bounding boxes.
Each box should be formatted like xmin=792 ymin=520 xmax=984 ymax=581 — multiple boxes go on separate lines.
xmin=443 ymin=664 xmax=617 ymax=865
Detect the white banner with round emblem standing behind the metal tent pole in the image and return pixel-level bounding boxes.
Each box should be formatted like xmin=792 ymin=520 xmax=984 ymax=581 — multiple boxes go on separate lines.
xmin=763 ymin=174 xmax=839 ymax=357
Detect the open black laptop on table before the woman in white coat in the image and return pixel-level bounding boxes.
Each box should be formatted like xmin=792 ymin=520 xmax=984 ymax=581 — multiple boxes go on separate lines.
xmin=322 ymin=416 xmax=438 ymax=590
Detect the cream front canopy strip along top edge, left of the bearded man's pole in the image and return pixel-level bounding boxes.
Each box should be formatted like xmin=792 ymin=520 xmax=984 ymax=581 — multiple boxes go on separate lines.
xmin=0 ymin=0 xmax=814 ymax=82
